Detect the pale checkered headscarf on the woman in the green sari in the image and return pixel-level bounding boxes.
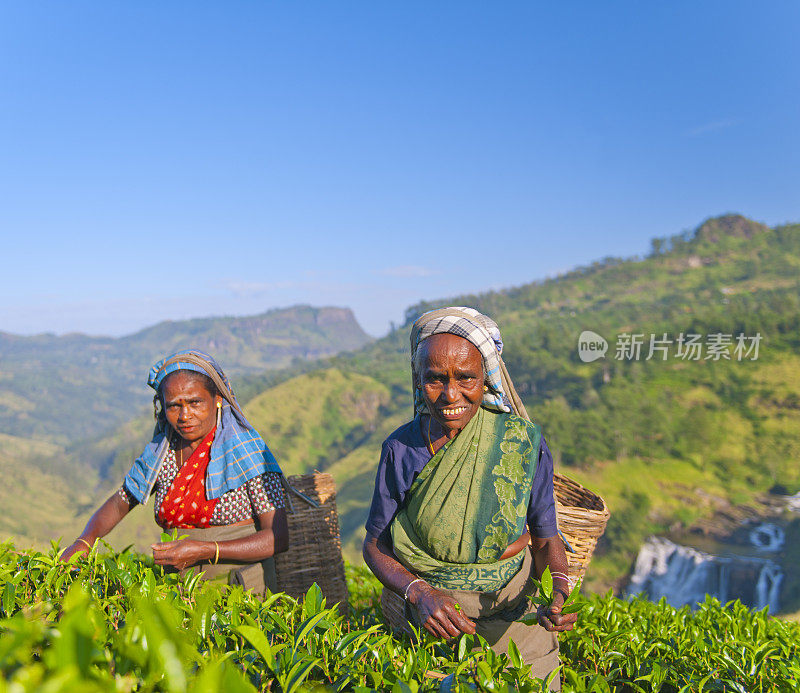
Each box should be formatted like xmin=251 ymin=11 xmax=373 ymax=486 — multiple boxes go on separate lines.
xmin=411 ymin=306 xmax=528 ymax=418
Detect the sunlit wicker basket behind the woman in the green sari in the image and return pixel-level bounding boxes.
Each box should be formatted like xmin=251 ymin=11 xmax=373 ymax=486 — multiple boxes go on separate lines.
xmin=553 ymin=474 xmax=611 ymax=579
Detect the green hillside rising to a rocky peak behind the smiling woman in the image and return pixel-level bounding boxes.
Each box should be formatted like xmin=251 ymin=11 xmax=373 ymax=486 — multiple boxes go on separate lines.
xmin=7 ymin=216 xmax=800 ymax=608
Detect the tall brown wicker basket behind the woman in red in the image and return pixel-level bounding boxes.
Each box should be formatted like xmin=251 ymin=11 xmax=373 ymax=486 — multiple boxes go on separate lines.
xmin=275 ymin=472 xmax=348 ymax=610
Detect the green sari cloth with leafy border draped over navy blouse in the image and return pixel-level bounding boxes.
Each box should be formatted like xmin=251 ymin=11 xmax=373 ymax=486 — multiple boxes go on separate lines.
xmin=392 ymin=407 xmax=541 ymax=592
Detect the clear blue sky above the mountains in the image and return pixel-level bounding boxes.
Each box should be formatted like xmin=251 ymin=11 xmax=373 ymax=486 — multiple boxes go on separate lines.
xmin=0 ymin=0 xmax=800 ymax=335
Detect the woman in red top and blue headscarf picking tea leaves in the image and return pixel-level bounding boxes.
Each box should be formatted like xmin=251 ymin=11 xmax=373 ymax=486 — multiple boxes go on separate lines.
xmin=62 ymin=350 xmax=288 ymax=592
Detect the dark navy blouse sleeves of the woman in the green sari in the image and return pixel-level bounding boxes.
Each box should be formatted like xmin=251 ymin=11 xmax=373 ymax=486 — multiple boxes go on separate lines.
xmin=366 ymin=417 xmax=558 ymax=543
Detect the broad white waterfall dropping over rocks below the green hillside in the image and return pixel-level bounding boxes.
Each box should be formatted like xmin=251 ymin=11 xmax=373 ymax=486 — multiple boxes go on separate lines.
xmin=627 ymin=537 xmax=783 ymax=612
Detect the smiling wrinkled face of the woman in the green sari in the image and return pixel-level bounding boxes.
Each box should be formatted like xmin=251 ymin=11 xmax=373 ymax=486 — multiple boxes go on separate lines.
xmin=417 ymin=334 xmax=483 ymax=431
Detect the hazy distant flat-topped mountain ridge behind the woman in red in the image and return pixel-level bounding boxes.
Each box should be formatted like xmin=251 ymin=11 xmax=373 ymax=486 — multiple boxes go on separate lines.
xmin=0 ymin=306 xmax=370 ymax=444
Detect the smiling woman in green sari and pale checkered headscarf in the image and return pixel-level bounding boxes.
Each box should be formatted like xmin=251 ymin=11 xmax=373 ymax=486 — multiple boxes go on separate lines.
xmin=364 ymin=307 xmax=576 ymax=688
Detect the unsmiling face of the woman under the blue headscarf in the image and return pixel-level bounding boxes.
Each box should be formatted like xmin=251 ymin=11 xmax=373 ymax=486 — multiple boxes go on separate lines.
xmin=161 ymin=373 xmax=222 ymax=443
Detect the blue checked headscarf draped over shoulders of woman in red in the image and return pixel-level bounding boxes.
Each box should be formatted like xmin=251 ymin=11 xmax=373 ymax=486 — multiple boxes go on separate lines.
xmin=119 ymin=349 xmax=281 ymax=503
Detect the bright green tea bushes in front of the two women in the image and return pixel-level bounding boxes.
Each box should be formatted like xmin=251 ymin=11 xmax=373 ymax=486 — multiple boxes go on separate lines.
xmin=0 ymin=543 xmax=800 ymax=693
